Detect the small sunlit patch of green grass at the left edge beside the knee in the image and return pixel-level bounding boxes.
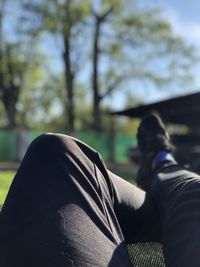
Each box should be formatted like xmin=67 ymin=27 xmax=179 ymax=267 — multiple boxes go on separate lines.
xmin=0 ymin=171 xmax=15 ymax=205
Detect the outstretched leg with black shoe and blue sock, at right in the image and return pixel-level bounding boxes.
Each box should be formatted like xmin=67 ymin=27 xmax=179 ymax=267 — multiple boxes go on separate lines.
xmin=138 ymin=114 xmax=200 ymax=267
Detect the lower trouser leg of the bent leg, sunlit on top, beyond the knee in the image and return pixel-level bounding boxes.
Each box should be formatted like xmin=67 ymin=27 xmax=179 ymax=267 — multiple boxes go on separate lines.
xmin=108 ymin=171 xmax=161 ymax=244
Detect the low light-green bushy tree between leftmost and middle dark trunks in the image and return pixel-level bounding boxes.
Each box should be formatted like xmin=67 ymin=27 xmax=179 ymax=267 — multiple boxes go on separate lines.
xmin=17 ymin=69 xmax=66 ymax=131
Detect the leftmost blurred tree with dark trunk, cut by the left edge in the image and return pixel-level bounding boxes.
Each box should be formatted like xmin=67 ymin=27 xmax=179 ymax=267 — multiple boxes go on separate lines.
xmin=0 ymin=0 xmax=35 ymax=129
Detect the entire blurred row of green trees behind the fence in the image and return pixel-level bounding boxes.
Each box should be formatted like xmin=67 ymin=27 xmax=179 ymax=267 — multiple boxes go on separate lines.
xmin=0 ymin=0 xmax=197 ymax=133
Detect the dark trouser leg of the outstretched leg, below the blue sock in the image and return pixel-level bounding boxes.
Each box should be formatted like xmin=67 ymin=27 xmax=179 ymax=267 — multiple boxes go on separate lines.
xmin=151 ymin=164 xmax=200 ymax=267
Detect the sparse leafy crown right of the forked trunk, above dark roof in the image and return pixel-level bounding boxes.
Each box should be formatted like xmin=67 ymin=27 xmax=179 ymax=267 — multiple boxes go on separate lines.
xmin=116 ymin=5 xmax=196 ymax=92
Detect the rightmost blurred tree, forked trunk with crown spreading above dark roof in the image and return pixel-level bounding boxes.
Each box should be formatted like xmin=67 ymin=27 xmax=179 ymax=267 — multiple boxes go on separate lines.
xmin=88 ymin=1 xmax=196 ymax=130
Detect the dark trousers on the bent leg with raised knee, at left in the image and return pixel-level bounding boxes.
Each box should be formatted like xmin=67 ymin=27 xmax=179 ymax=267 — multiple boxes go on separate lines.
xmin=0 ymin=134 xmax=159 ymax=267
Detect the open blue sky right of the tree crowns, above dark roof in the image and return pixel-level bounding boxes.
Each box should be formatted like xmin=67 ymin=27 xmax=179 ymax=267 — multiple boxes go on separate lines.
xmin=139 ymin=0 xmax=200 ymax=102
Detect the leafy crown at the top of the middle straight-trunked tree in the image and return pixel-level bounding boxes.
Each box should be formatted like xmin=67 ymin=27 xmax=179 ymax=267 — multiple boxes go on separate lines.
xmin=22 ymin=0 xmax=89 ymax=40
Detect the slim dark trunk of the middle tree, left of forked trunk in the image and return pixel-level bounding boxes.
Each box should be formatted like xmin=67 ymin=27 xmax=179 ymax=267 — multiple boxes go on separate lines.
xmin=63 ymin=37 xmax=74 ymax=133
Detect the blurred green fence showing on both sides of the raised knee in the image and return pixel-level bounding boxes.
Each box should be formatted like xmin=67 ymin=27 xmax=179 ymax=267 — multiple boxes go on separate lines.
xmin=0 ymin=130 xmax=136 ymax=162
